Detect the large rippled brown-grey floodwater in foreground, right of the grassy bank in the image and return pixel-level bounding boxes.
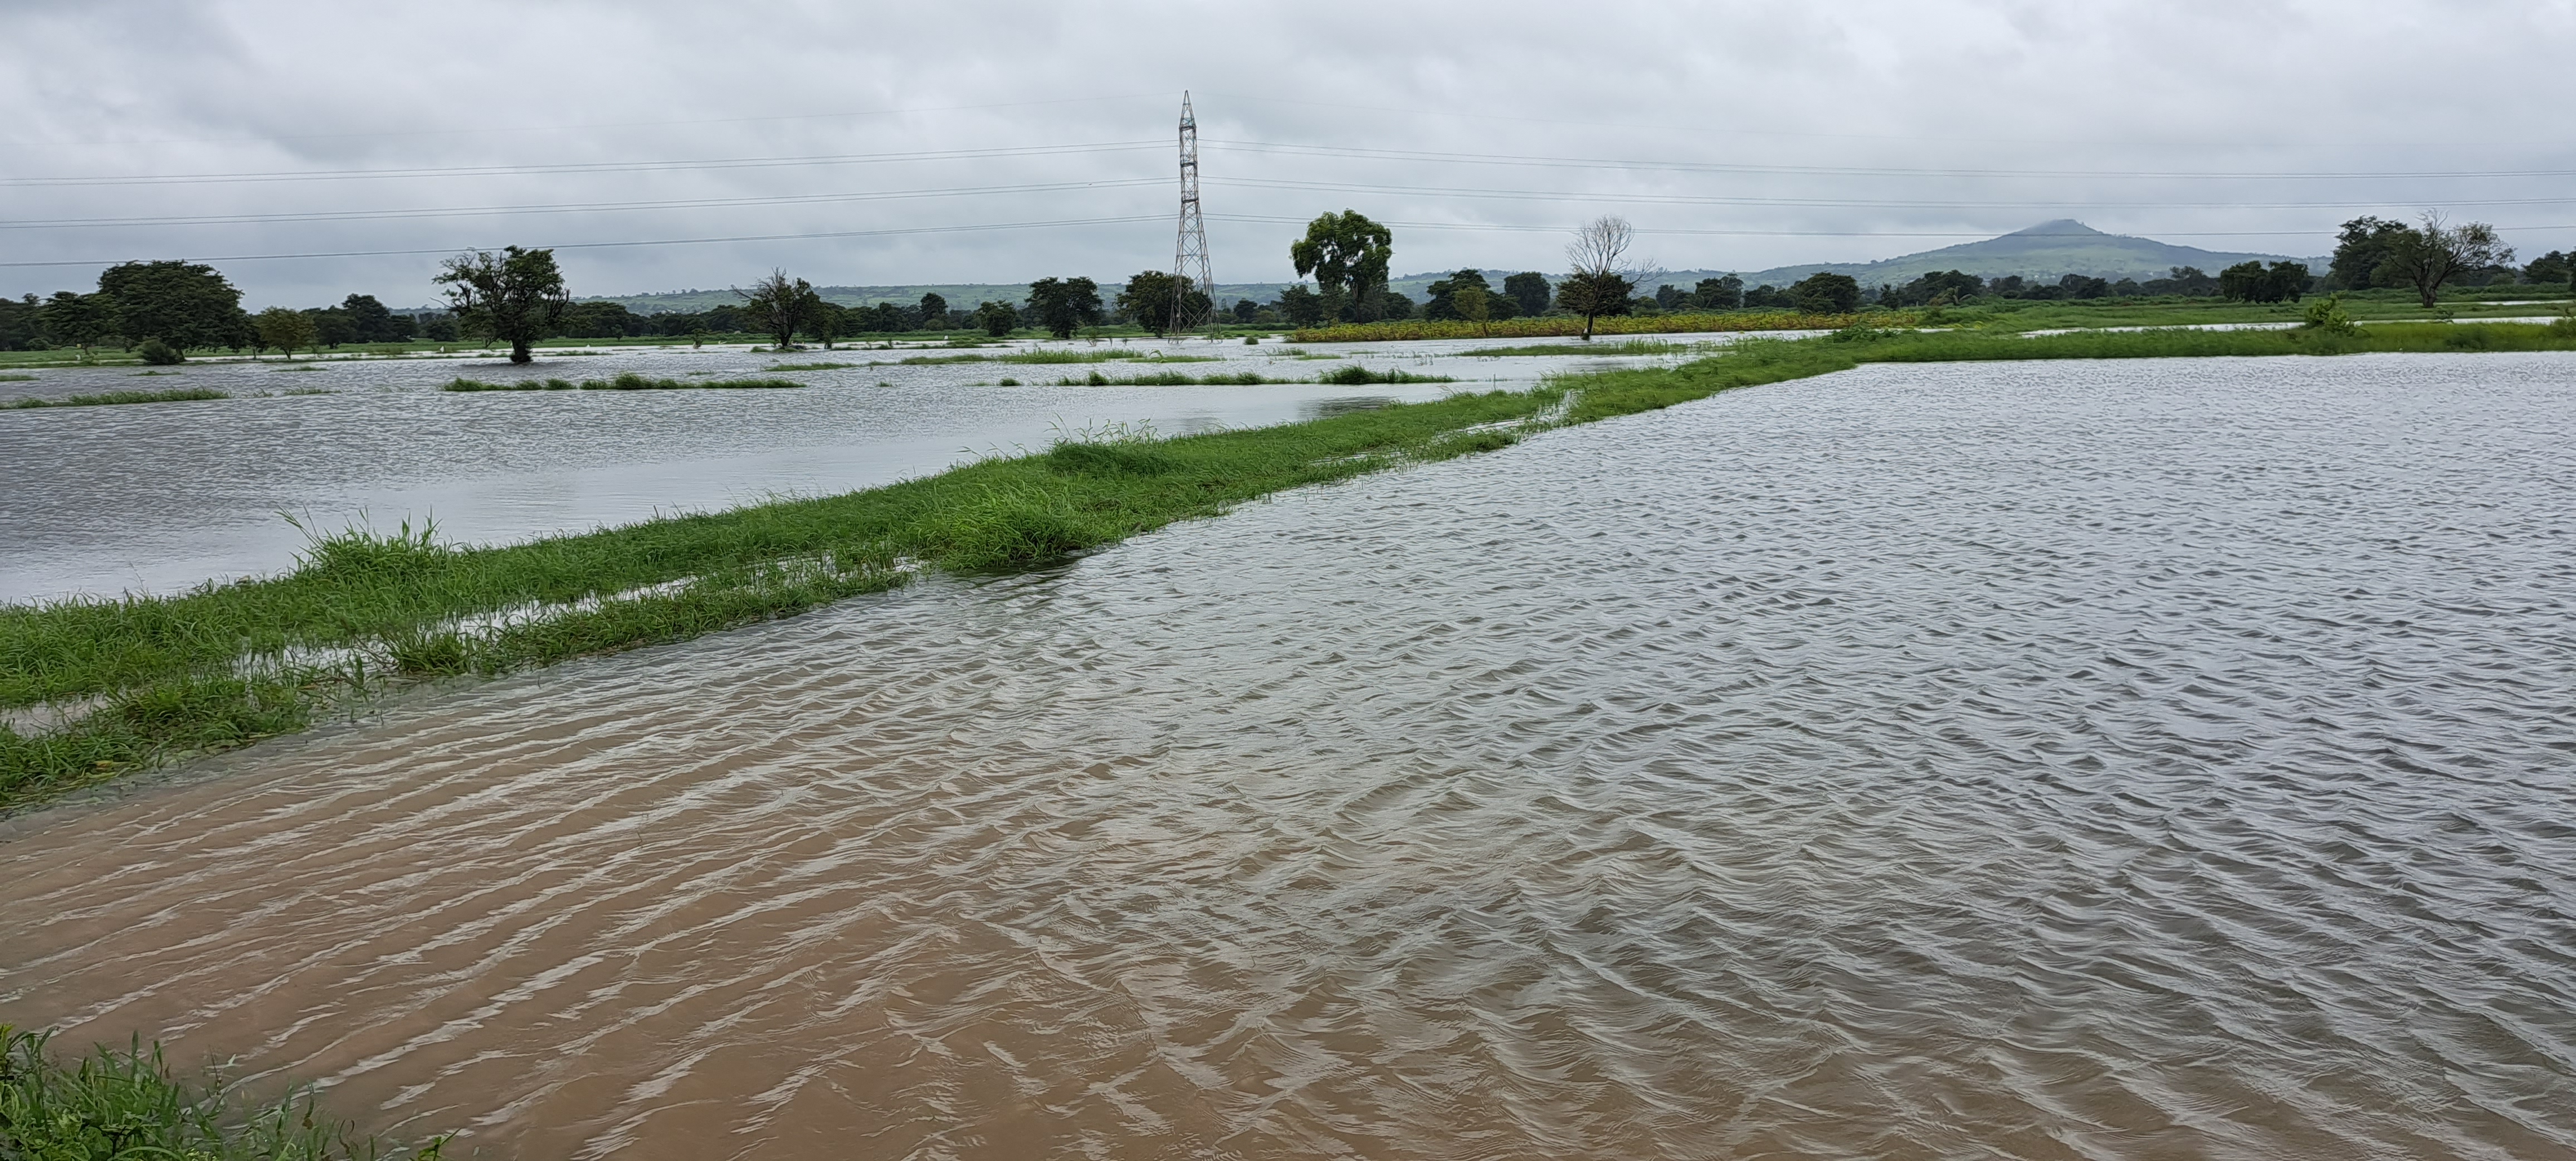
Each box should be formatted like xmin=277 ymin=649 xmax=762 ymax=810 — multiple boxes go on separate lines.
xmin=0 ymin=355 xmax=2576 ymax=1158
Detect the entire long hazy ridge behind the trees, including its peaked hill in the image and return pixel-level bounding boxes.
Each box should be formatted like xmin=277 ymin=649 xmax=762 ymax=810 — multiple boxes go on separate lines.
xmin=564 ymin=219 xmax=2326 ymax=314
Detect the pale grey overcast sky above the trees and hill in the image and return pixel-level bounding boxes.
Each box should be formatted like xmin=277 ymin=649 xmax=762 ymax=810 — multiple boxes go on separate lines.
xmin=0 ymin=0 xmax=2576 ymax=309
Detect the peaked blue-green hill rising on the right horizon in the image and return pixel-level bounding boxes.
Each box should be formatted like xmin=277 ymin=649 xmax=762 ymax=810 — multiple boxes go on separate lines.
xmin=1720 ymin=219 xmax=2326 ymax=286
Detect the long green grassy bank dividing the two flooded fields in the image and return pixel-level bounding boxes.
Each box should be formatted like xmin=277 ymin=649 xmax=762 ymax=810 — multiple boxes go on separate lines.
xmin=0 ymin=319 xmax=2576 ymax=811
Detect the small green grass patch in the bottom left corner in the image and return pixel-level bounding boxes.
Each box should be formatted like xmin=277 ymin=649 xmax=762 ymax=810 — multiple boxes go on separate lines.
xmin=0 ymin=1025 xmax=443 ymax=1161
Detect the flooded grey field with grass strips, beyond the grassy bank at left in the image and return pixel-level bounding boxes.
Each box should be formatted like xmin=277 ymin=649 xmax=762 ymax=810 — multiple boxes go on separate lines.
xmin=0 ymin=329 xmax=1710 ymax=600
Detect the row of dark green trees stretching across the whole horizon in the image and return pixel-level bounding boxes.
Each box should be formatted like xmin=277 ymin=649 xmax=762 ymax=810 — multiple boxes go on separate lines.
xmin=0 ymin=211 xmax=2576 ymax=363
